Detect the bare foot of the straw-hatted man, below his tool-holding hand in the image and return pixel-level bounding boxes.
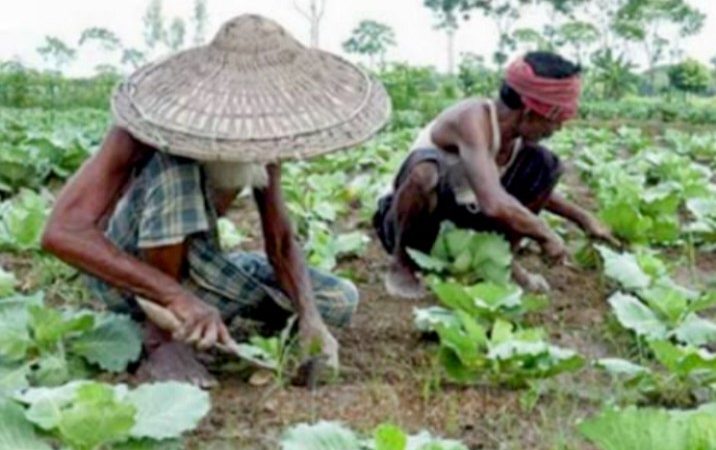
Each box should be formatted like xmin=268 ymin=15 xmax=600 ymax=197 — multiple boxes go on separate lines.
xmin=137 ymin=342 xmax=218 ymax=389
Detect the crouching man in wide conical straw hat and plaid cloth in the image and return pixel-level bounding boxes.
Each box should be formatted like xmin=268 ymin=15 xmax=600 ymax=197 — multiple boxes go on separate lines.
xmin=43 ymin=16 xmax=390 ymax=385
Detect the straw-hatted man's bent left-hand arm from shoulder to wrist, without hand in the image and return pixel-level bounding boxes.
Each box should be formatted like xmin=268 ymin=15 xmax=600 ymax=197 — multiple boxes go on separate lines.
xmin=42 ymin=127 xmax=196 ymax=305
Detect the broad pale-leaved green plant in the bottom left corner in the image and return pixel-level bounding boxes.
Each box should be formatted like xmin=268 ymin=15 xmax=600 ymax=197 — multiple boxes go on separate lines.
xmin=0 ymin=381 xmax=210 ymax=450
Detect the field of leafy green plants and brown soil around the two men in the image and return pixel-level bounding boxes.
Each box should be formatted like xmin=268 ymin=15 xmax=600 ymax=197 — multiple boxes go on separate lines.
xmin=0 ymin=97 xmax=716 ymax=449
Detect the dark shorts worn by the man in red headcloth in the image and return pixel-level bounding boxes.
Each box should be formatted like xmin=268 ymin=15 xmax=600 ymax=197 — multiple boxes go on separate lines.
xmin=373 ymin=145 xmax=563 ymax=253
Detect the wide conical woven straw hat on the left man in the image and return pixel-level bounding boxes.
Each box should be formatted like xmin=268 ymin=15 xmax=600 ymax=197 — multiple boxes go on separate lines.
xmin=112 ymin=15 xmax=390 ymax=162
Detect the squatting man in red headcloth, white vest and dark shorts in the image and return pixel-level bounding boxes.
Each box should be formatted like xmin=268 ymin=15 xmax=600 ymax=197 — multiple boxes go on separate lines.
xmin=374 ymin=52 xmax=613 ymax=298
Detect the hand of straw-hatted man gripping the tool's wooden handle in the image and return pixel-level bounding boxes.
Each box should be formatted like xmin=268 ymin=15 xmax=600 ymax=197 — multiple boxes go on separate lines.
xmin=167 ymin=293 xmax=232 ymax=350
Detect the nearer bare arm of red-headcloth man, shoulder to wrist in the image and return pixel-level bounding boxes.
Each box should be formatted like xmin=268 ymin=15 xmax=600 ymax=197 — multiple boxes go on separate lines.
xmin=434 ymin=107 xmax=559 ymax=246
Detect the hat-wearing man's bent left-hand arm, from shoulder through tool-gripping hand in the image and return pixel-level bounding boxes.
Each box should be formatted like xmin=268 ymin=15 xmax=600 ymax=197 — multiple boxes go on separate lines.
xmin=42 ymin=127 xmax=230 ymax=346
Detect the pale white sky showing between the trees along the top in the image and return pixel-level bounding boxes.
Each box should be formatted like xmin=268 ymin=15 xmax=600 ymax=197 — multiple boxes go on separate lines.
xmin=0 ymin=0 xmax=716 ymax=75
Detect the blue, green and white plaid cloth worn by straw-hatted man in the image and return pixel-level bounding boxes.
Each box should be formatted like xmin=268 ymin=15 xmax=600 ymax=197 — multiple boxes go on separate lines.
xmin=89 ymin=152 xmax=358 ymax=326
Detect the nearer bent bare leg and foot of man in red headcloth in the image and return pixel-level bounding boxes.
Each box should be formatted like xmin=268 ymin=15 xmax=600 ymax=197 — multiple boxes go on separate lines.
xmin=383 ymin=161 xmax=440 ymax=298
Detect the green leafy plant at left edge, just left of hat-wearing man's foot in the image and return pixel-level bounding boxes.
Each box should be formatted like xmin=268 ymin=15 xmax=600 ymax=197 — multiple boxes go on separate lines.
xmin=0 ymin=292 xmax=141 ymax=392
